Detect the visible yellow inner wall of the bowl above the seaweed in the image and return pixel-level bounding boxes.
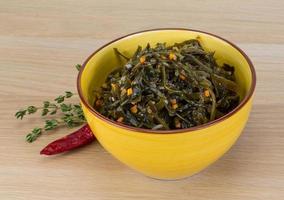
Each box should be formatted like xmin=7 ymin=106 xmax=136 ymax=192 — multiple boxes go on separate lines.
xmin=79 ymin=29 xmax=253 ymax=119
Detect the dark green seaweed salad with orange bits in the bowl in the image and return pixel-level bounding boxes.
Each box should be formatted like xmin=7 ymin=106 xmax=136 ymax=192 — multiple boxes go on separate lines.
xmin=94 ymin=39 xmax=240 ymax=130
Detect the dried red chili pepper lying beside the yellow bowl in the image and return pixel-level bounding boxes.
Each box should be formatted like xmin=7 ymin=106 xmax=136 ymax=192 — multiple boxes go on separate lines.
xmin=40 ymin=124 xmax=95 ymax=155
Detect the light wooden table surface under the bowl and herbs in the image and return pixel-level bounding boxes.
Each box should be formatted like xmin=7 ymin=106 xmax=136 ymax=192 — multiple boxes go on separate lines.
xmin=0 ymin=0 xmax=284 ymax=200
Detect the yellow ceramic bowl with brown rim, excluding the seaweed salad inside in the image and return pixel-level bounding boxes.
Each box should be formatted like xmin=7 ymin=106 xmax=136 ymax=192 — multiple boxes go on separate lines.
xmin=78 ymin=29 xmax=256 ymax=179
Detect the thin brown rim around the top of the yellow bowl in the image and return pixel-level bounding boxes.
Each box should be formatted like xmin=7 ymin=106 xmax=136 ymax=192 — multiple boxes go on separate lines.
xmin=77 ymin=28 xmax=256 ymax=134
